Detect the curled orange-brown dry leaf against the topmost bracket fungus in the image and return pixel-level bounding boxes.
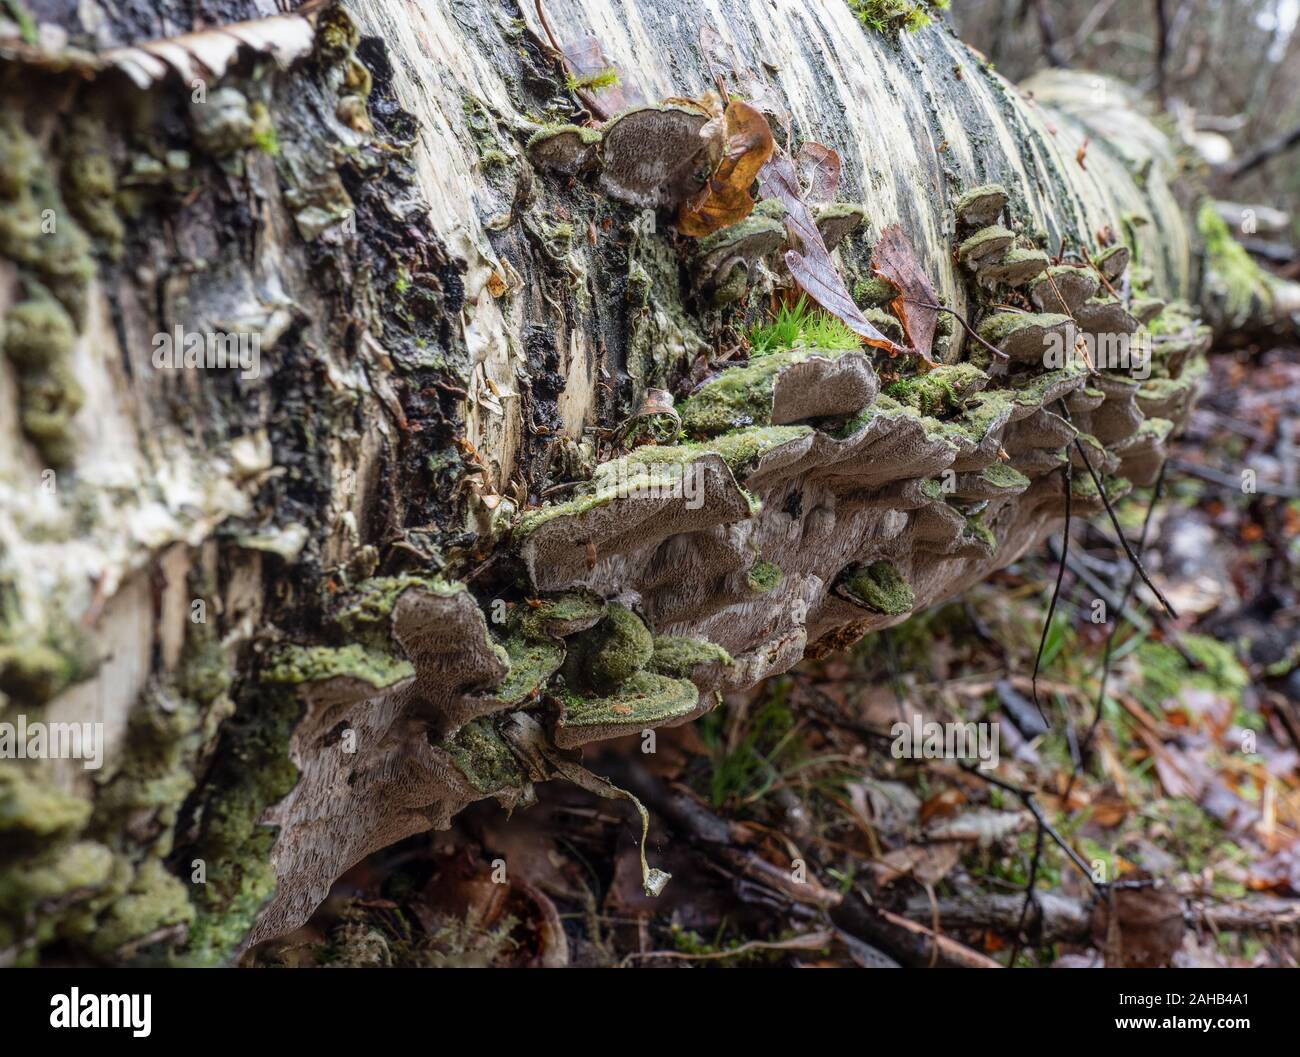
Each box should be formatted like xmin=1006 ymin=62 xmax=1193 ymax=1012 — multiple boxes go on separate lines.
xmin=677 ymin=99 xmax=775 ymax=238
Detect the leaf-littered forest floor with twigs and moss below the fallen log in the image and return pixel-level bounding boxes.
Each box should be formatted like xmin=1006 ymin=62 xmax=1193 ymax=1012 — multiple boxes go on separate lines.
xmin=246 ymin=348 xmax=1300 ymax=966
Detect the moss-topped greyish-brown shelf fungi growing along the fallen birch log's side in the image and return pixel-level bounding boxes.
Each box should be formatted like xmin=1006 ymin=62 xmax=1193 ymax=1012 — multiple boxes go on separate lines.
xmin=254 ymin=163 xmax=1209 ymax=939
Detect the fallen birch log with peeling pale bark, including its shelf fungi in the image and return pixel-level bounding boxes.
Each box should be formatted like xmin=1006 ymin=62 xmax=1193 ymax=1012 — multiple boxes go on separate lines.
xmin=0 ymin=0 xmax=1279 ymax=963
